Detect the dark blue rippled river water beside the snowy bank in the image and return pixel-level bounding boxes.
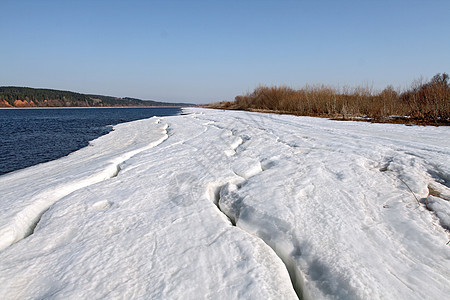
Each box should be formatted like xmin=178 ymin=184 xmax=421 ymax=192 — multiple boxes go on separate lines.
xmin=0 ymin=107 xmax=181 ymax=175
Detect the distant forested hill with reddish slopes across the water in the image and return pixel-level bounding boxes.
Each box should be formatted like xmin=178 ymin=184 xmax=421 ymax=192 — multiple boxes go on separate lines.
xmin=0 ymin=86 xmax=195 ymax=107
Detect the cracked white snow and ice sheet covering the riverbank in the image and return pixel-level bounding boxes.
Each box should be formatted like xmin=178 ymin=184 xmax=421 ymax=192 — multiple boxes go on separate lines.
xmin=0 ymin=109 xmax=450 ymax=299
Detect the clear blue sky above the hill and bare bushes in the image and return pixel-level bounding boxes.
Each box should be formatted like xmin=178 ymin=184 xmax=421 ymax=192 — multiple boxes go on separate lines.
xmin=0 ymin=0 xmax=450 ymax=103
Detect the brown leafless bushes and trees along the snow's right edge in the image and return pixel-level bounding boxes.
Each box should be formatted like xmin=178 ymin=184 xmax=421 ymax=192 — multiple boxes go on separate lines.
xmin=207 ymin=73 xmax=450 ymax=125
